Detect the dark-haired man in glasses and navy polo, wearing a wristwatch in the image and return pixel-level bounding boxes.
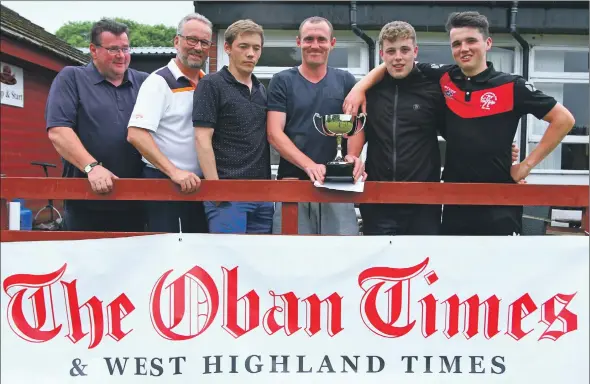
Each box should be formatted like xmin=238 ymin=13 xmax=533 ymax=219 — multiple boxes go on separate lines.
xmin=45 ymin=20 xmax=148 ymax=232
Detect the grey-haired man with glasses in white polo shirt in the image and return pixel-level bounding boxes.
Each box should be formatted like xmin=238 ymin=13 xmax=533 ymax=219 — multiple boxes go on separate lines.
xmin=127 ymin=13 xmax=212 ymax=233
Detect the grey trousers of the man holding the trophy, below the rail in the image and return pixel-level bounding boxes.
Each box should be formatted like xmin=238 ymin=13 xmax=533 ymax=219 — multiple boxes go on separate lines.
xmin=272 ymin=203 xmax=359 ymax=235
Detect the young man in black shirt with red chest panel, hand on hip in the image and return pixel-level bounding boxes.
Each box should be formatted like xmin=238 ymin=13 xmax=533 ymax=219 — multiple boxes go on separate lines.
xmin=345 ymin=12 xmax=574 ymax=236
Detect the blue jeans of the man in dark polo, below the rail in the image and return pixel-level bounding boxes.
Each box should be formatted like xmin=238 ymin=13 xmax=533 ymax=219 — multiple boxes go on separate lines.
xmin=204 ymin=201 xmax=274 ymax=234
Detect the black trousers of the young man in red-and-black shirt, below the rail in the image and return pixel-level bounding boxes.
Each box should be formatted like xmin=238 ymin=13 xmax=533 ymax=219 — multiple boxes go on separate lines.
xmin=442 ymin=205 xmax=522 ymax=236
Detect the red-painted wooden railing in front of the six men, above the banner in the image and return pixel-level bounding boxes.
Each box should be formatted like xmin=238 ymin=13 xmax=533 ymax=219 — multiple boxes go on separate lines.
xmin=0 ymin=177 xmax=589 ymax=242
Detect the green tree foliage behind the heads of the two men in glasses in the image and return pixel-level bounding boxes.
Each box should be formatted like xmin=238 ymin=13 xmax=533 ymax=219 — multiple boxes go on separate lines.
xmin=55 ymin=18 xmax=176 ymax=47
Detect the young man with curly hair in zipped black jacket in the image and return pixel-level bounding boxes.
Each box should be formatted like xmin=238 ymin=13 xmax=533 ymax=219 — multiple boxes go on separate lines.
xmin=346 ymin=21 xmax=445 ymax=235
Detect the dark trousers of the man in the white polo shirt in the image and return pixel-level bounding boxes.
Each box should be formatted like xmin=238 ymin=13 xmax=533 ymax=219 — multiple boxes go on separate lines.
xmin=143 ymin=166 xmax=209 ymax=233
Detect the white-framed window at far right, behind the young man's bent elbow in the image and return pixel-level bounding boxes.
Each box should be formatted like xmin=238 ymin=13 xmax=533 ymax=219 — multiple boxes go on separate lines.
xmin=528 ymin=46 xmax=590 ymax=173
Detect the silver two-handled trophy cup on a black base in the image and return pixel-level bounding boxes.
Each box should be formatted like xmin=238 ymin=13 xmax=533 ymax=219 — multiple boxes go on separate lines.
xmin=313 ymin=113 xmax=367 ymax=183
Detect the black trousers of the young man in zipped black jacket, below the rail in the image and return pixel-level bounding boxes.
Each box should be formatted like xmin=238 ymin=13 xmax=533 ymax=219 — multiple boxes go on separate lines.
xmin=359 ymin=204 xmax=441 ymax=236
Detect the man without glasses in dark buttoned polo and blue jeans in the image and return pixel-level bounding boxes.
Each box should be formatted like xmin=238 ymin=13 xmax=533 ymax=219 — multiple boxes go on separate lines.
xmin=193 ymin=20 xmax=274 ymax=234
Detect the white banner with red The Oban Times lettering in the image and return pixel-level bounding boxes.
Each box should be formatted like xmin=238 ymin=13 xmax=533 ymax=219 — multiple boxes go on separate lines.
xmin=1 ymin=234 xmax=590 ymax=384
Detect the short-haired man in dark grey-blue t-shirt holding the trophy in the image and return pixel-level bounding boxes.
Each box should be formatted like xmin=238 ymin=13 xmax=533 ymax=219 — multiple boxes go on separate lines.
xmin=267 ymin=17 xmax=364 ymax=235
